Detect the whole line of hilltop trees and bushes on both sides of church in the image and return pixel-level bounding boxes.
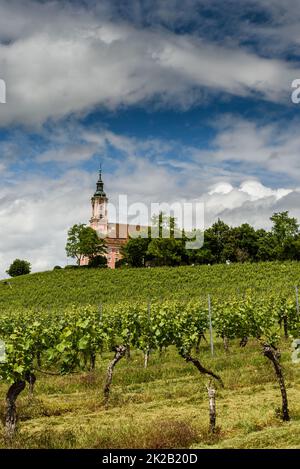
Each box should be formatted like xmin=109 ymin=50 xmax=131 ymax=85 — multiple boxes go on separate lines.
xmin=7 ymin=211 xmax=300 ymax=277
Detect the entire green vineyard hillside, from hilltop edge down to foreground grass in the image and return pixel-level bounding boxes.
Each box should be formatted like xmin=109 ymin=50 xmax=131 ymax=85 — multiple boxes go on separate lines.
xmin=0 ymin=263 xmax=300 ymax=447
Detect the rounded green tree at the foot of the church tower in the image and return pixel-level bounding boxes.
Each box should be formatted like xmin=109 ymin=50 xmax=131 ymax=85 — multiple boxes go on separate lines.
xmin=66 ymin=224 xmax=106 ymax=265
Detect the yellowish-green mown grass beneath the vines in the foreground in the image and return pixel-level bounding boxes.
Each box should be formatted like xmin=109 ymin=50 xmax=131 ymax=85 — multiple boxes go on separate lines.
xmin=0 ymin=334 xmax=300 ymax=448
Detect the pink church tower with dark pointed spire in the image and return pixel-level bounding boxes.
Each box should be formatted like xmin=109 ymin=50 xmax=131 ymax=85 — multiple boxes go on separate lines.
xmin=90 ymin=169 xmax=108 ymax=237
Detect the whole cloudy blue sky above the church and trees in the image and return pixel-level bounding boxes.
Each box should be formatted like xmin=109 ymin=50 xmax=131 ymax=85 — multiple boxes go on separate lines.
xmin=0 ymin=0 xmax=300 ymax=278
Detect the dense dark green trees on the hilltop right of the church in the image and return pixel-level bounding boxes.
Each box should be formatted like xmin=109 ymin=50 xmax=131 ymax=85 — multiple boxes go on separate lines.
xmin=123 ymin=212 xmax=300 ymax=267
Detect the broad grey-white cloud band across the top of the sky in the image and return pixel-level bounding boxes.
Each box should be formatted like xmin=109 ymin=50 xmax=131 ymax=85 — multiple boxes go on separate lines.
xmin=0 ymin=0 xmax=300 ymax=125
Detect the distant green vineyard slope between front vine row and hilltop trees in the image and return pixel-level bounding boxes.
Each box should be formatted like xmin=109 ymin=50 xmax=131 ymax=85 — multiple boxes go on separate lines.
xmin=0 ymin=262 xmax=300 ymax=310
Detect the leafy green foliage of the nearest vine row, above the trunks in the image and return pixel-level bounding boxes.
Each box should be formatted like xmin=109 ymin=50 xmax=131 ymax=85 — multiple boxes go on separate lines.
xmin=0 ymin=290 xmax=300 ymax=382
